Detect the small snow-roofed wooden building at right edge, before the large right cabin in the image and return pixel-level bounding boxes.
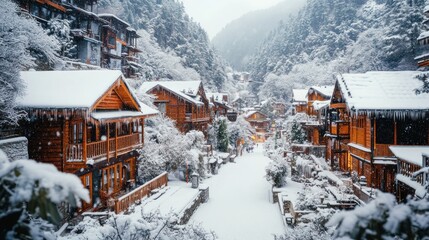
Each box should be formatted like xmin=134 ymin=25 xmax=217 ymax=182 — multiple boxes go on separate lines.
xmin=390 ymin=146 xmax=429 ymax=201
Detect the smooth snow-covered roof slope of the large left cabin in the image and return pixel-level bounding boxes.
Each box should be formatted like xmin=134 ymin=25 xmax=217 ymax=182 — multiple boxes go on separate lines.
xmin=16 ymin=69 xmax=122 ymax=109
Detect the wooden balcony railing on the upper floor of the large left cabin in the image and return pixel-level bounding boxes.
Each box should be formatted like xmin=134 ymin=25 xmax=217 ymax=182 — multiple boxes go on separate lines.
xmin=66 ymin=133 xmax=142 ymax=161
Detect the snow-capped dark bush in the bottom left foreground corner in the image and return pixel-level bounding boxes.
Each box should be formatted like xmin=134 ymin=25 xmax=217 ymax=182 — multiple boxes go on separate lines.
xmin=0 ymin=150 xmax=89 ymax=239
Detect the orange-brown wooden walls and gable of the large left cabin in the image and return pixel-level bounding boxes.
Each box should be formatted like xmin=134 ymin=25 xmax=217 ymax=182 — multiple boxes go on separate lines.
xmin=20 ymin=70 xmax=157 ymax=210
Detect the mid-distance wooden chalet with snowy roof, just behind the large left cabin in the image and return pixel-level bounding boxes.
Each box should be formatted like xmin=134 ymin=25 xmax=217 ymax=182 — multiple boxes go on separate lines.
xmin=139 ymin=81 xmax=211 ymax=134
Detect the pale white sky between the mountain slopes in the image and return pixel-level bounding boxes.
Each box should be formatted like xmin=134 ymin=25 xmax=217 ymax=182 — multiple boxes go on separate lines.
xmin=181 ymin=0 xmax=283 ymax=39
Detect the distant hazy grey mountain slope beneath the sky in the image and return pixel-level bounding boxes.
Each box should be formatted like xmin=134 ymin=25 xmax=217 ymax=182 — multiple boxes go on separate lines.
xmin=212 ymin=0 xmax=306 ymax=70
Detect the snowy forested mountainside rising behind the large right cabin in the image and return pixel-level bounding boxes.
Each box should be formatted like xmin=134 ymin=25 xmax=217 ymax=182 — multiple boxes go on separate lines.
xmin=247 ymin=0 xmax=425 ymax=100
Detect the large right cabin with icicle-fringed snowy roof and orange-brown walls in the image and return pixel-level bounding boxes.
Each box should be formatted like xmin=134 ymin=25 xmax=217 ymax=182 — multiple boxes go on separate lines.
xmin=327 ymin=71 xmax=429 ymax=195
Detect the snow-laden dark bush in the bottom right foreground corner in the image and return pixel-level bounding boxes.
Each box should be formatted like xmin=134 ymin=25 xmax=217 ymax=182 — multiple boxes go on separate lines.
xmin=327 ymin=192 xmax=429 ymax=239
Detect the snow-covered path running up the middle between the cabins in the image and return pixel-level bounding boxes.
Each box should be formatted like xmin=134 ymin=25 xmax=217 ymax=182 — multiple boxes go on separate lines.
xmin=191 ymin=146 xmax=284 ymax=240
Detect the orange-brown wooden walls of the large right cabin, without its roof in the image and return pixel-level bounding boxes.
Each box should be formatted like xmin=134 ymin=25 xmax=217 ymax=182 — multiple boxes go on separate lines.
xmin=326 ymin=74 xmax=429 ymax=196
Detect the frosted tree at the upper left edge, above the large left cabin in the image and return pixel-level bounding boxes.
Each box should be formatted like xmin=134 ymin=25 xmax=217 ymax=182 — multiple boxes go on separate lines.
xmin=0 ymin=0 xmax=58 ymax=124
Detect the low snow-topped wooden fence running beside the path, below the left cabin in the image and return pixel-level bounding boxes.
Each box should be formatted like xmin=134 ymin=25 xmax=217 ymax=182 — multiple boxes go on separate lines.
xmin=115 ymin=172 xmax=168 ymax=214
